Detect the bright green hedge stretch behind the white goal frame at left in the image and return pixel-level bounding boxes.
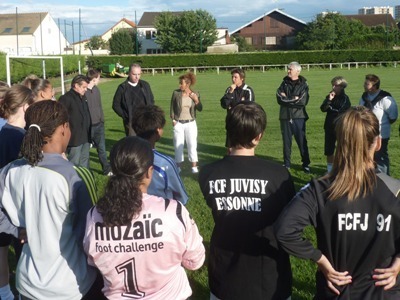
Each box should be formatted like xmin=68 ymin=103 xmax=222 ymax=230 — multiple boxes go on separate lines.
xmin=0 ymin=53 xmax=86 ymax=83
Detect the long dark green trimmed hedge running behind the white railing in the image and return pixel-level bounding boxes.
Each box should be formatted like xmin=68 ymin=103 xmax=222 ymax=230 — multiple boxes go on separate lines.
xmin=87 ymin=50 xmax=400 ymax=68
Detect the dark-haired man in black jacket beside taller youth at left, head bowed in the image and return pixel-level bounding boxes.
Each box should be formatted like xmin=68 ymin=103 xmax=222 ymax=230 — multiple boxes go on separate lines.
xmin=59 ymin=75 xmax=91 ymax=168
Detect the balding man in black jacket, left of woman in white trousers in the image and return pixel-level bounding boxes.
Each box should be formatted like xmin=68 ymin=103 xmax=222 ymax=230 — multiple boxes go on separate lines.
xmin=113 ymin=64 xmax=154 ymax=136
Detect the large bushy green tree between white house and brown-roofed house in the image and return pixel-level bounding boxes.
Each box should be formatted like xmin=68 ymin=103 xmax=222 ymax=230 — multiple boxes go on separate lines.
xmin=155 ymin=9 xmax=217 ymax=53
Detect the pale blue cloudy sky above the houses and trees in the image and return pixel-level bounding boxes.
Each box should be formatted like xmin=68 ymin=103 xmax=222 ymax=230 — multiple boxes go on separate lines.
xmin=0 ymin=0 xmax=400 ymax=42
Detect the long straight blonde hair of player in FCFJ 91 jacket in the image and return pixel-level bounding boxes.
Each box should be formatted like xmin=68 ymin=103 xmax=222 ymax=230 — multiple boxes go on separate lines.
xmin=328 ymin=106 xmax=379 ymax=201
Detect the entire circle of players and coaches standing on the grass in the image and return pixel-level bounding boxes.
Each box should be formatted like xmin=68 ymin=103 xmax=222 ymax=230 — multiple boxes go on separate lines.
xmin=0 ymin=62 xmax=400 ymax=300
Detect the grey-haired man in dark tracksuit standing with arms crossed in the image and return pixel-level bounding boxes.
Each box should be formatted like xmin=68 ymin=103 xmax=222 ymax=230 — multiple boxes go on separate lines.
xmin=276 ymin=62 xmax=310 ymax=173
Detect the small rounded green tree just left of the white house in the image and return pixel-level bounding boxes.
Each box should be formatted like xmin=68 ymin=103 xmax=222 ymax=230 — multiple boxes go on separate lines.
xmin=108 ymin=29 xmax=141 ymax=55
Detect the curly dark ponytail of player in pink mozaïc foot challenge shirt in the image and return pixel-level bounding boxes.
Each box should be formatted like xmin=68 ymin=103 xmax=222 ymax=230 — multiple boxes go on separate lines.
xmin=96 ymin=136 xmax=154 ymax=226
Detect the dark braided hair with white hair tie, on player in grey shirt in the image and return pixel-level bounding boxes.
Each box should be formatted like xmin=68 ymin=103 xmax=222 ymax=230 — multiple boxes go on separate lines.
xmin=21 ymin=100 xmax=68 ymax=166
